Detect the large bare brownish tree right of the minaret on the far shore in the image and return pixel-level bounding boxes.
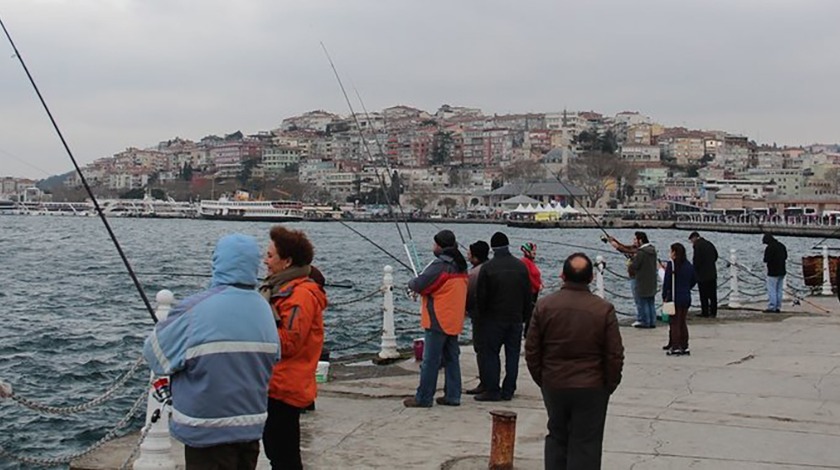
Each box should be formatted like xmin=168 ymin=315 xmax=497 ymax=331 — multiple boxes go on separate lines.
xmin=569 ymin=152 xmax=636 ymax=205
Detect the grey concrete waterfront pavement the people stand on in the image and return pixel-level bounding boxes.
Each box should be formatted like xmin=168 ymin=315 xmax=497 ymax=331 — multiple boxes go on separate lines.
xmin=72 ymin=297 xmax=840 ymax=470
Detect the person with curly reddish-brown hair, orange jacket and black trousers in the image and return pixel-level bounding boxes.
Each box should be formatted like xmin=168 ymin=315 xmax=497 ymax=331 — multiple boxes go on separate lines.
xmin=260 ymin=225 xmax=327 ymax=469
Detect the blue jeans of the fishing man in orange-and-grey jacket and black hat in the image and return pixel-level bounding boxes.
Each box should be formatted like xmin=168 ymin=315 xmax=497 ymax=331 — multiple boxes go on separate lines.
xmin=414 ymin=330 xmax=461 ymax=406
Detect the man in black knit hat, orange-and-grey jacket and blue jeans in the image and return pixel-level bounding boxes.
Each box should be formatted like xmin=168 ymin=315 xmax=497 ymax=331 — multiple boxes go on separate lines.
xmin=403 ymin=230 xmax=468 ymax=408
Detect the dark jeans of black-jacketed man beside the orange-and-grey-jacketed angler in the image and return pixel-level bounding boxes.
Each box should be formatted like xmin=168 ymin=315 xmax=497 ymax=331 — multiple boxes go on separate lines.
xmin=478 ymin=320 xmax=522 ymax=398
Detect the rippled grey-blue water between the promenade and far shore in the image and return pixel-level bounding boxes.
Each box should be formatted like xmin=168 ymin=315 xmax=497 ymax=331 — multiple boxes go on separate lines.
xmin=0 ymin=216 xmax=828 ymax=468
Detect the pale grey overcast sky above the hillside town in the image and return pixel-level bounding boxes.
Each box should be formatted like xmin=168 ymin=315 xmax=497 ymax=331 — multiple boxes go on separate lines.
xmin=0 ymin=0 xmax=840 ymax=178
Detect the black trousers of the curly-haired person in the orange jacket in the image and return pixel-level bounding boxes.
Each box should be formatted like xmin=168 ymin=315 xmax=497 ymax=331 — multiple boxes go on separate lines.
xmin=263 ymin=398 xmax=303 ymax=470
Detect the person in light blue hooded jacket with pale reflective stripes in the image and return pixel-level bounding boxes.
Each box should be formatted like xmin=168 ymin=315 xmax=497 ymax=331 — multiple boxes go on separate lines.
xmin=143 ymin=234 xmax=280 ymax=470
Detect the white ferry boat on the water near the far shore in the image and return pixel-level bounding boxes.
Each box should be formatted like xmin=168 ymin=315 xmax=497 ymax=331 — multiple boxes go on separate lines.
xmin=198 ymin=198 xmax=303 ymax=222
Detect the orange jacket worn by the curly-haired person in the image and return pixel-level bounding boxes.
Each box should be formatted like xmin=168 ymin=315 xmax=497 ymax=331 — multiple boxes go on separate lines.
xmin=268 ymin=277 xmax=327 ymax=408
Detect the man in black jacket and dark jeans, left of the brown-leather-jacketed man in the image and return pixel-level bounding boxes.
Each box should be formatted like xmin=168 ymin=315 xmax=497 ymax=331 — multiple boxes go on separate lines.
xmin=475 ymin=232 xmax=533 ymax=401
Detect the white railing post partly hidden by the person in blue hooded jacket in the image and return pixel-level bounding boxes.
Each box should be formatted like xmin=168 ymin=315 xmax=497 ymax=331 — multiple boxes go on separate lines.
xmin=134 ymin=290 xmax=175 ymax=470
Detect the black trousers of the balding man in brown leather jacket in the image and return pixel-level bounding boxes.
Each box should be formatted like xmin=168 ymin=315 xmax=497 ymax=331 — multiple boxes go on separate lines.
xmin=542 ymin=388 xmax=610 ymax=470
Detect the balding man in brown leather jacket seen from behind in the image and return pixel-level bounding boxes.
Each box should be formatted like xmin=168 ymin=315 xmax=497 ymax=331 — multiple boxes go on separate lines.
xmin=525 ymin=253 xmax=624 ymax=470
